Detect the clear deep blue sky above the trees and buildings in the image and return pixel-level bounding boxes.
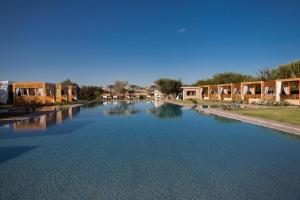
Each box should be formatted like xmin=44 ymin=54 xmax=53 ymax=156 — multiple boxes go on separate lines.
xmin=0 ymin=0 xmax=300 ymax=85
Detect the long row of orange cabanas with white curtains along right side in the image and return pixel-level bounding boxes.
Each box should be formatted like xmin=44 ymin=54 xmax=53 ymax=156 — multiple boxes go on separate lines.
xmin=182 ymin=78 xmax=300 ymax=105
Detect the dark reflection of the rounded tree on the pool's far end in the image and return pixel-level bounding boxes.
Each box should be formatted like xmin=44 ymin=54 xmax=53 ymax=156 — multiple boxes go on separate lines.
xmin=149 ymin=104 xmax=182 ymax=119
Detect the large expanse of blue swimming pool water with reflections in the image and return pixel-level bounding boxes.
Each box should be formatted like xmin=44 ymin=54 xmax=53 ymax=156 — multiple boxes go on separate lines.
xmin=0 ymin=103 xmax=300 ymax=200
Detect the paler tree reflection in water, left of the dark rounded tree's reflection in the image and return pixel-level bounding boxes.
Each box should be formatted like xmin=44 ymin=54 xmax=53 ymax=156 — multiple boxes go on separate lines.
xmin=103 ymin=102 xmax=140 ymax=116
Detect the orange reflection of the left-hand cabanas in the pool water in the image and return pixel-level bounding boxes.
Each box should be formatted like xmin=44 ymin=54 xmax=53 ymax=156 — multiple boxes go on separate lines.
xmin=12 ymin=107 xmax=80 ymax=131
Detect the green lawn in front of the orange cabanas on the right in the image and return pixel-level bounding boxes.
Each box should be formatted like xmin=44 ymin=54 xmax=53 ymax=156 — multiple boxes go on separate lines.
xmin=231 ymin=107 xmax=300 ymax=125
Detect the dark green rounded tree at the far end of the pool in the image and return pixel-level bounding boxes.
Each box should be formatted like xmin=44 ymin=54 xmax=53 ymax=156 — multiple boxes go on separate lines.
xmin=155 ymin=78 xmax=182 ymax=96
